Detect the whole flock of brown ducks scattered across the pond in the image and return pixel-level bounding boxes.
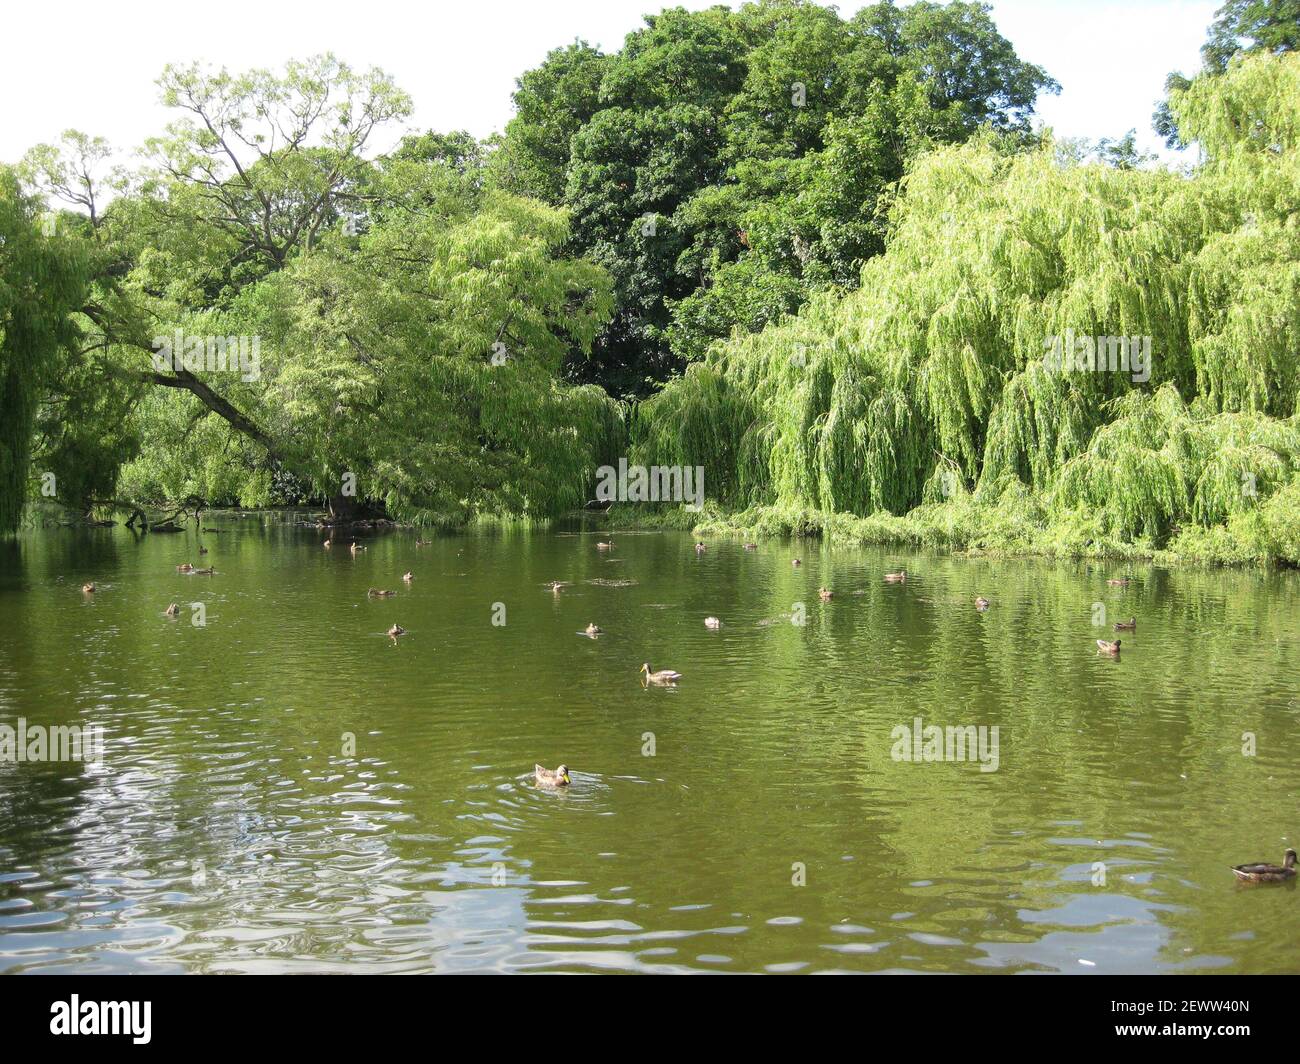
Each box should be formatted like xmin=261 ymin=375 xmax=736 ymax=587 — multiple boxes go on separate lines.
xmin=82 ymin=529 xmax=1296 ymax=883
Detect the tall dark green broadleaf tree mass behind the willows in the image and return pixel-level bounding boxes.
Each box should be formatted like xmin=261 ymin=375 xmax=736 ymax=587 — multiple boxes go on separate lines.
xmin=491 ymin=0 xmax=1057 ymax=394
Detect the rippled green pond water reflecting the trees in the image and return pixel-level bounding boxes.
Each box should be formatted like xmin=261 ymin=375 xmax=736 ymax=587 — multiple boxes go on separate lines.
xmin=0 ymin=515 xmax=1300 ymax=973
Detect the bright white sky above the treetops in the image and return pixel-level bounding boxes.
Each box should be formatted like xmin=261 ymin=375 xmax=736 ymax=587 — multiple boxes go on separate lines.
xmin=0 ymin=0 xmax=1221 ymax=163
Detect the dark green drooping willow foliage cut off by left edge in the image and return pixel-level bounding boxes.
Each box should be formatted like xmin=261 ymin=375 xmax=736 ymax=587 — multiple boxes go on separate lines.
xmin=0 ymin=166 xmax=87 ymax=535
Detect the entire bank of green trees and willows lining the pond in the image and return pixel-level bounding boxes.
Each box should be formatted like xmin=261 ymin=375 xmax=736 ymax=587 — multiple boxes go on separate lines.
xmin=0 ymin=0 xmax=1300 ymax=562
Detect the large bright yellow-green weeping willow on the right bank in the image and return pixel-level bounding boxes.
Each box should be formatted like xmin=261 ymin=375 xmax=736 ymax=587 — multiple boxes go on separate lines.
xmin=634 ymin=49 xmax=1300 ymax=559
